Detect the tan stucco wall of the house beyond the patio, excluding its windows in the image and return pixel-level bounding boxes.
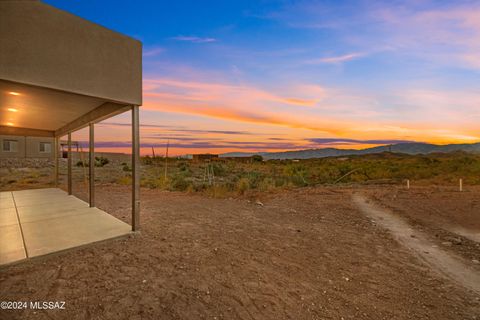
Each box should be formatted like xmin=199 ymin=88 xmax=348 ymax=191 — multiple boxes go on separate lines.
xmin=0 ymin=135 xmax=55 ymax=158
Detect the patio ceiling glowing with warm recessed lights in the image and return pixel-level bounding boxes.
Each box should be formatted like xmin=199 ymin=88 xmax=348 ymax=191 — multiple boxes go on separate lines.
xmin=0 ymin=80 xmax=130 ymax=136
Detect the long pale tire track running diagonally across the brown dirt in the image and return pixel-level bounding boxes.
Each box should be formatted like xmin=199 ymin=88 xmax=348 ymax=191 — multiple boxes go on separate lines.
xmin=352 ymin=194 xmax=480 ymax=294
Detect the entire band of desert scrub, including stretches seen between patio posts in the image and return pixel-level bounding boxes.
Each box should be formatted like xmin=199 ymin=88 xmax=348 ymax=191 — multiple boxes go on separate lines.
xmin=0 ymin=152 xmax=480 ymax=197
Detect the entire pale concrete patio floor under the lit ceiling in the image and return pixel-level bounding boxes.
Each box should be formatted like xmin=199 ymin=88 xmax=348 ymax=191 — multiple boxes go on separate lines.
xmin=0 ymin=188 xmax=131 ymax=265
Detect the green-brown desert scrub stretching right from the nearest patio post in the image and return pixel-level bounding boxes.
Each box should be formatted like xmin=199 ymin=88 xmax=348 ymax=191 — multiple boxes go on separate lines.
xmin=127 ymin=152 xmax=480 ymax=196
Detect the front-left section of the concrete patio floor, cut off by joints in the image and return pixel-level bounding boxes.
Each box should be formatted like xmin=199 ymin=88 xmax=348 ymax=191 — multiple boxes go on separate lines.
xmin=0 ymin=224 xmax=27 ymax=265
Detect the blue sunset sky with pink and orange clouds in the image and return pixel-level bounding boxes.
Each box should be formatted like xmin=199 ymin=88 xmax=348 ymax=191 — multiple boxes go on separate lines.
xmin=44 ymin=0 xmax=480 ymax=155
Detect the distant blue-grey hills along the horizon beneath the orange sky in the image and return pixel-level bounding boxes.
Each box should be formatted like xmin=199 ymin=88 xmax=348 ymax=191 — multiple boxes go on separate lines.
xmin=220 ymin=142 xmax=480 ymax=160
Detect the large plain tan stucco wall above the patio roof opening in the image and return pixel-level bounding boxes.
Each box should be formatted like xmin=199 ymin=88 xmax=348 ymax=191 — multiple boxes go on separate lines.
xmin=0 ymin=0 xmax=142 ymax=105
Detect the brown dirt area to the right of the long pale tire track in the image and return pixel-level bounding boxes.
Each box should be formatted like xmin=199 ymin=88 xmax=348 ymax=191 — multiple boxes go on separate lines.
xmin=364 ymin=186 xmax=480 ymax=261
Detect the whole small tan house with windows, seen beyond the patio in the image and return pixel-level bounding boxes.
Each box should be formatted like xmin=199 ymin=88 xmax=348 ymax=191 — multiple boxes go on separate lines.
xmin=0 ymin=135 xmax=55 ymax=158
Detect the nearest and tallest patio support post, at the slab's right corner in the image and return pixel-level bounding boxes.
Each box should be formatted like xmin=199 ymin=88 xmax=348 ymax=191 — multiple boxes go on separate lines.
xmin=132 ymin=106 xmax=140 ymax=231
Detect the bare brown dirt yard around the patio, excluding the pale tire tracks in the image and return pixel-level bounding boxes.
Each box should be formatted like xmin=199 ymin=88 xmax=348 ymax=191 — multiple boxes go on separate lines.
xmin=0 ymin=185 xmax=480 ymax=320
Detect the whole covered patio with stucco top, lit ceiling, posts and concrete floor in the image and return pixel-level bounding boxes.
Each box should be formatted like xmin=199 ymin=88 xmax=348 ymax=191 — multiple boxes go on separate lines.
xmin=0 ymin=1 xmax=142 ymax=265
